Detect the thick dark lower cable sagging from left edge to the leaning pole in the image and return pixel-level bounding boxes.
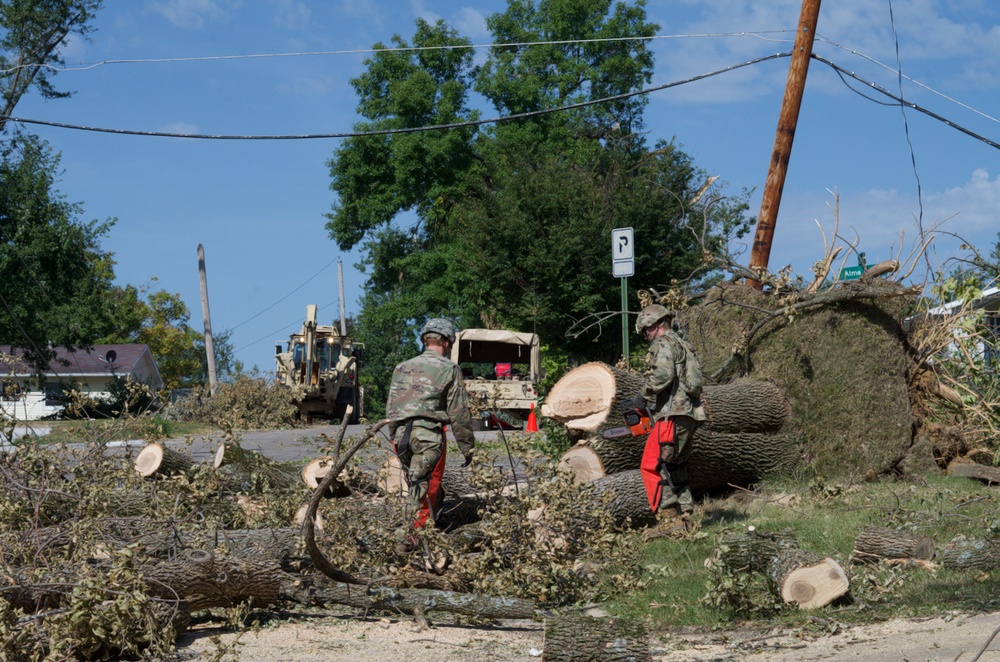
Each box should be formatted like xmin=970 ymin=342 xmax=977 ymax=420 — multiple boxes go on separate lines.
xmin=0 ymin=51 xmax=791 ymax=140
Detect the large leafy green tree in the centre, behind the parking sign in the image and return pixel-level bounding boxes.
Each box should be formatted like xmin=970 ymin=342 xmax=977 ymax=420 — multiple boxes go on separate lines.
xmin=327 ymin=0 xmax=748 ymax=409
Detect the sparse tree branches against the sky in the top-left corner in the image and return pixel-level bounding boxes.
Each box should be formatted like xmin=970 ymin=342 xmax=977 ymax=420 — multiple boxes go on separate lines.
xmin=0 ymin=0 xmax=104 ymax=130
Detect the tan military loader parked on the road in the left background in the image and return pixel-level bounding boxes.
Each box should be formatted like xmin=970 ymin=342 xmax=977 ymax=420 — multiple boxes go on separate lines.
xmin=274 ymin=304 xmax=364 ymax=423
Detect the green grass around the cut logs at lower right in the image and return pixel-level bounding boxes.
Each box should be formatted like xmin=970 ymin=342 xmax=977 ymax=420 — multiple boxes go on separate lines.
xmin=608 ymin=476 xmax=1000 ymax=628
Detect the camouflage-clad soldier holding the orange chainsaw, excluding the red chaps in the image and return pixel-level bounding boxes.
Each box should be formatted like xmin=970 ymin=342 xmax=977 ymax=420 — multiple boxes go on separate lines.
xmin=635 ymin=304 xmax=706 ymax=526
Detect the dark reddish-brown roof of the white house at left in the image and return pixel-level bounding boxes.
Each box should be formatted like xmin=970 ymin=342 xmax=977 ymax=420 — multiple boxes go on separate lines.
xmin=0 ymin=344 xmax=163 ymax=388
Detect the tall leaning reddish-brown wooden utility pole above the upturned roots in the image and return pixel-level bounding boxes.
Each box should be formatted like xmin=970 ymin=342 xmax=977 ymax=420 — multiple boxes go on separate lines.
xmin=750 ymin=0 xmax=820 ymax=289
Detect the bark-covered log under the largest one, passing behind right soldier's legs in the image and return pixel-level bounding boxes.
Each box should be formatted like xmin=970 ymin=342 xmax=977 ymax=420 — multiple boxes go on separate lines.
xmin=560 ymin=425 xmax=802 ymax=492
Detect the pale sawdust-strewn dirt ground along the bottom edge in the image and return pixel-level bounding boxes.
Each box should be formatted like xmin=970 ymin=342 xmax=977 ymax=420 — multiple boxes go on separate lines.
xmin=178 ymin=613 xmax=1000 ymax=662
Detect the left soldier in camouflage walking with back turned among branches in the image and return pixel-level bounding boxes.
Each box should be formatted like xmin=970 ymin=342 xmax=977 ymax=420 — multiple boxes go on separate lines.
xmin=386 ymin=318 xmax=475 ymax=546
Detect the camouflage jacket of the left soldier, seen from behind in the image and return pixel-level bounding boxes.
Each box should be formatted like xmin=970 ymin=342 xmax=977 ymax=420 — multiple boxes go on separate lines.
xmin=385 ymin=349 xmax=475 ymax=455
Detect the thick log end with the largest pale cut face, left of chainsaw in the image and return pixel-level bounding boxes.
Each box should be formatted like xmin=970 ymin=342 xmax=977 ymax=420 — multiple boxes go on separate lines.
xmin=542 ymin=362 xmax=644 ymax=432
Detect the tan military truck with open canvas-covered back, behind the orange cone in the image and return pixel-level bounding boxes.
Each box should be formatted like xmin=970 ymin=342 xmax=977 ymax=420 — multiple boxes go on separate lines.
xmin=451 ymin=329 xmax=544 ymax=429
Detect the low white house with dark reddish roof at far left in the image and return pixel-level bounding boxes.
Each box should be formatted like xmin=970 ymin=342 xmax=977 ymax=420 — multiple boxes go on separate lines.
xmin=0 ymin=345 xmax=163 ymax=421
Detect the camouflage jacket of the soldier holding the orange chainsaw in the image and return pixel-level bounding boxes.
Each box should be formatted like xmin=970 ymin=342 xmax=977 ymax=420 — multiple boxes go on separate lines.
xmin=642 ymin=331 xmax=707 ymax=421
